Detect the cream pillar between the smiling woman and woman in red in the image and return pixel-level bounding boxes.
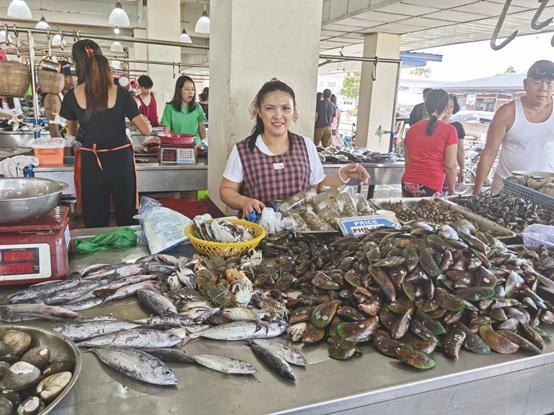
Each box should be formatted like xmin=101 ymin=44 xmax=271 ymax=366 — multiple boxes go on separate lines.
xmin=356 ymin=33 xmax=400 ymax=152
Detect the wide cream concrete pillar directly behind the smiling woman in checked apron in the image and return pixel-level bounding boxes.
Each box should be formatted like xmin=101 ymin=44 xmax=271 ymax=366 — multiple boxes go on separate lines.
xmin=208 ymin=0 xmax=322 ymax=211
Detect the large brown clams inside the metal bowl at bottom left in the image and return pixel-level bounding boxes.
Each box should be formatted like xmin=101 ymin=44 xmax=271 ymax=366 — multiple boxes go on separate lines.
xmin=0 ymin=329 xmax=73 ymax=415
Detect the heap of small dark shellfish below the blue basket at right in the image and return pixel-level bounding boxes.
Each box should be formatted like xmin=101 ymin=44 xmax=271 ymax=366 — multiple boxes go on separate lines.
xmin=449 ymin=193 xmax=554 ymax=233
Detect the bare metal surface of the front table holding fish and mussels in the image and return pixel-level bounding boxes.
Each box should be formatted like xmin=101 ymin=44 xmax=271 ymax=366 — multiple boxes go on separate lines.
xmin=0 ymin=228 xmax=554 ymax=415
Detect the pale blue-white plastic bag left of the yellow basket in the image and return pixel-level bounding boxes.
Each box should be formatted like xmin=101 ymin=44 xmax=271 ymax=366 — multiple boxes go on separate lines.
xmin=137 ymin=196 xmax=192 ymax=255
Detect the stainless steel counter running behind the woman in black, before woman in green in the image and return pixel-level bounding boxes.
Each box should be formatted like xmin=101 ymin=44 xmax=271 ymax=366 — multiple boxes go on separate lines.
xmin=34 ymin=159 xmax=208 ymax=195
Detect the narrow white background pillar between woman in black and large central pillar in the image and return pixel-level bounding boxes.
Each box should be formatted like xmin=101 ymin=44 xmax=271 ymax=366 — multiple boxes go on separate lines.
xmin=146 ymin=0 xmax=181 ymax=117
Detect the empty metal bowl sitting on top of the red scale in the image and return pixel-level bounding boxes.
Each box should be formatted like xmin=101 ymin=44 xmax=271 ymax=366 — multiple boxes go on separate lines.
xmin=0 ymin=177 xmax=67 ymax=224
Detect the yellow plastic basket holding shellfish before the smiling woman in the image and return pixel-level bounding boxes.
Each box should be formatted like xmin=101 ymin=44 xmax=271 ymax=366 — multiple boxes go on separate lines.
xmin=185 ymin=219 xmax=266 ymax=257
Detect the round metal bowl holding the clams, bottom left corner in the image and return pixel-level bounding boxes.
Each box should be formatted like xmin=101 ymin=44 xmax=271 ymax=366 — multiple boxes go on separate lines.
xmin=0 ymin=325 xmax=83 ymax=415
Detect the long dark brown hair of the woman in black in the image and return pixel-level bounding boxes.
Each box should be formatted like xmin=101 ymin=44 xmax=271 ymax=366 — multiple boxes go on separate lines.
xmin=71 ymin=39 xmax=113 ymax=114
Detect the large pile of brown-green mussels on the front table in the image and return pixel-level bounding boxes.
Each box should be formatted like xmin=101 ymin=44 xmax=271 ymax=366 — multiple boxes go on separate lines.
xmin=254 ymin=228 xmax=554 ymax=369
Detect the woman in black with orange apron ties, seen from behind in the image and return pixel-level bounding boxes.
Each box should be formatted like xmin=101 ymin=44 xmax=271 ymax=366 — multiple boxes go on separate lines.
xmin=60 ymin=39 xmax=151 ymax=228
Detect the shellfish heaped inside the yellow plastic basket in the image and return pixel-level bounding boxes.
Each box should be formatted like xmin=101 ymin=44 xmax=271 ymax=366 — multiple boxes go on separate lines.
xmin=193 ymin=213 xmax=254 ymax=242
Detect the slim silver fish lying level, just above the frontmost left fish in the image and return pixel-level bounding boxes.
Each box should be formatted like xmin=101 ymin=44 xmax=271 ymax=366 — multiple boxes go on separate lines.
xmin=77 ymin=328 xmax=181 ymax=349
